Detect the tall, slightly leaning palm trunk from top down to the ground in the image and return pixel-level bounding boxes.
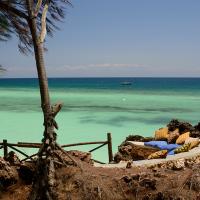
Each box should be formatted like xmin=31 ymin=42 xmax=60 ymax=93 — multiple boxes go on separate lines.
xmin=26 ymin=0 xmax=56 ymax=200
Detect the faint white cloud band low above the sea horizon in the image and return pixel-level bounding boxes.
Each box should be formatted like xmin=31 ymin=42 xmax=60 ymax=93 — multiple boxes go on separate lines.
xmin=4 ymin=63 xmax=145 ymax=77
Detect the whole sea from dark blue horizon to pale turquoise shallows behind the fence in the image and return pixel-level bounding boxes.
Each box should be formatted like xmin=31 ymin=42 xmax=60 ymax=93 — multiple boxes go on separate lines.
xmin=0 ymin=78 xmax=200 ymax=161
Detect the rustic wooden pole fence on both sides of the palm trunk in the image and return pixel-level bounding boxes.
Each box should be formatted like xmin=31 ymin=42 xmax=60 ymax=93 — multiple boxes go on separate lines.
xmin=0 ymin=133 xmax=113 ymax=164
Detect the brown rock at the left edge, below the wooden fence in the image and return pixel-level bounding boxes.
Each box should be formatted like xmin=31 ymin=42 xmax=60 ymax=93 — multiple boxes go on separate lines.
xmin=0 ymin=157 xmax=18 ymax=188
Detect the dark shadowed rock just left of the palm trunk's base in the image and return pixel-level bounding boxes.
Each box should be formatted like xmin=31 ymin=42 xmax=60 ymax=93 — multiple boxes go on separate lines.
xmin=18 ymin=162 xmax=36 ymax=184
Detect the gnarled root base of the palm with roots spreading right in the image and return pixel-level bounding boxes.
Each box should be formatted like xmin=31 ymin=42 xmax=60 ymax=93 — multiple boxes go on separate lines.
xmin=29 ymin=143 xmax=82 ymax=200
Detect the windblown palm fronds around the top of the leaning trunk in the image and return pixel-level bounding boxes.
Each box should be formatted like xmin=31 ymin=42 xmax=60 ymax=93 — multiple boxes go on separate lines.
xmin=0 ymin=0 xmax=71 ymax=54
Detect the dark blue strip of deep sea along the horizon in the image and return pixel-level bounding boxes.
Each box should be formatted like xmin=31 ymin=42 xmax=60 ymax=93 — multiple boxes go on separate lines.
xmin=0 ymin=78 xmax=200 ymax=92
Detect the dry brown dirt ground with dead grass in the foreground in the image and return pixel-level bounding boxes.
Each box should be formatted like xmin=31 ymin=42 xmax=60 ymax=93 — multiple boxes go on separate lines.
xmin=0 ymin=161 xmax=200 ymax=200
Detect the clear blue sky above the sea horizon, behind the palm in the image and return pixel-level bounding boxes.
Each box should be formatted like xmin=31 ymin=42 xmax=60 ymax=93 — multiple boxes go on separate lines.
xmin=0 ymin=0 xmax=200 ymax=77
